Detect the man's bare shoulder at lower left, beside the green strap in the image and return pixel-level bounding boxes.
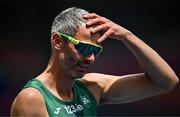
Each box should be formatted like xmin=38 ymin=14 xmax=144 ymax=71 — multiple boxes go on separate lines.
xmin=11 ymin=88 xmax=47 ymax=116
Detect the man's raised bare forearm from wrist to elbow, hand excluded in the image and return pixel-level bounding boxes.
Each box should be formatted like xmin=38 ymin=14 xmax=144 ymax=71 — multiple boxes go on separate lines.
xmin=121 ymin=32 xmax=178 ymax=89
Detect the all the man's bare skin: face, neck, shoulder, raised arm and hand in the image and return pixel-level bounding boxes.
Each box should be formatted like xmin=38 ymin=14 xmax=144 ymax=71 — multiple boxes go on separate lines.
xmin=11 ymin=13 xmax=179 ymax=116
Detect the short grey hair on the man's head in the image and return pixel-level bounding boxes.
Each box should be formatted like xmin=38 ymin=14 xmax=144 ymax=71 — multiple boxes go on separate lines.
xmin=51 ymin=7 xmax=89 ymax=36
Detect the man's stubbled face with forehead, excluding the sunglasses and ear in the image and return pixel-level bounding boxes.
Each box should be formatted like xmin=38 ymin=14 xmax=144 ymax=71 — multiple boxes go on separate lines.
xmin=64 ymin=23 xmax=100 ymax=78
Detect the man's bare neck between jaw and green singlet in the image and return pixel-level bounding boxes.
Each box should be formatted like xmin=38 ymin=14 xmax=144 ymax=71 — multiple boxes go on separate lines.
xmin=38 ymin=52 xmax=74 ymax=101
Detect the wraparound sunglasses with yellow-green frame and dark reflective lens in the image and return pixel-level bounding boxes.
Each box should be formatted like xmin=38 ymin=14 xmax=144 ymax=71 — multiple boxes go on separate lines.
xmin=59 ymin=33 xmax=103 ymax=57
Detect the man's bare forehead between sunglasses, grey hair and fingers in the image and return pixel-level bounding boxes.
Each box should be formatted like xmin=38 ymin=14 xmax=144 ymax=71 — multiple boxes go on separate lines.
xmin=73 ymin=22 xmax=101 ymax=44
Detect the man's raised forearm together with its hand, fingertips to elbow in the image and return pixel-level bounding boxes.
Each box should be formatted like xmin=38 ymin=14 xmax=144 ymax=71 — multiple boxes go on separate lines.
xmin=84 ymin=13 xmax=178 ymax=89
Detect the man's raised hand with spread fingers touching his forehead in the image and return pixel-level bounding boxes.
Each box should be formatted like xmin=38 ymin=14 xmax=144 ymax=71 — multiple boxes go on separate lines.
xmin=84 ymin=13 xmax=131 ymax=42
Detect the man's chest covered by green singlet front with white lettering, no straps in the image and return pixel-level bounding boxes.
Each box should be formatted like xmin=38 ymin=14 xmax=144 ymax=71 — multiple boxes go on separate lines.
xmin=46 ymin=95 xmax=96 ymax=117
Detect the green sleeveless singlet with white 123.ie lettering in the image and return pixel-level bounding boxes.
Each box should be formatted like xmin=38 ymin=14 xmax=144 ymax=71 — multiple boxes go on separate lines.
xmin=24 ymin=79 xmax=97 ymax=117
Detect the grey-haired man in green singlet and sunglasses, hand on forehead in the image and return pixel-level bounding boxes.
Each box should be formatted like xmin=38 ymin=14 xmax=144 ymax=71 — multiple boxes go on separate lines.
xmin=11 ymin=7 xmax=179 ymax=116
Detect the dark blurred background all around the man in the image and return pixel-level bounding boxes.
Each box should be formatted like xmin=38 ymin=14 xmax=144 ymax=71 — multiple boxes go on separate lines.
xmin=0 ymin=0 xmax=180 ymax=116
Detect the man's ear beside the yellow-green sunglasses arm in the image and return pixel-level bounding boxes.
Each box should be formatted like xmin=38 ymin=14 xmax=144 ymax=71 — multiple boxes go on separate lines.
xmin=51 ymin=33 xmax=62 ymax=50
